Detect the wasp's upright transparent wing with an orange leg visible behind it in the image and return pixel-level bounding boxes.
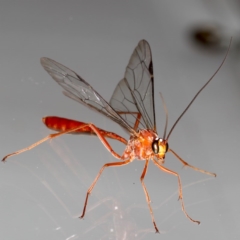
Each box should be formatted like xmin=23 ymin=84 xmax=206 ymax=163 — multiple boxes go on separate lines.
xmin=109 ymin=40 xmax=156 ymax=131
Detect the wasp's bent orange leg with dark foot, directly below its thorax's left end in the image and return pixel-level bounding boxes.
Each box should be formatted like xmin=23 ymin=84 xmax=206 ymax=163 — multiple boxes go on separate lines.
xmin=80 ymin=159 xmax=133 ymax=218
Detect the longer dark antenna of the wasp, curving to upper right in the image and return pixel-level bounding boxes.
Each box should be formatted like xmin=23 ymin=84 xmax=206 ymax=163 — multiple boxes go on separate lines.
xmin=166 ymin=37 xmax=232 ymax=141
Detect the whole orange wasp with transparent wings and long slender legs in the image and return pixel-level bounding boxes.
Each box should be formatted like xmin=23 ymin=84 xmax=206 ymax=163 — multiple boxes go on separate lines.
xmin=2 ymin=40 xmax=229 ymax=232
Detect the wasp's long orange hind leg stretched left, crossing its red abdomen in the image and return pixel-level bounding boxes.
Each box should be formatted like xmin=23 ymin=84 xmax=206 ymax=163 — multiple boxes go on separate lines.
xmin=2 ymin=123 xmax=124 ymax=162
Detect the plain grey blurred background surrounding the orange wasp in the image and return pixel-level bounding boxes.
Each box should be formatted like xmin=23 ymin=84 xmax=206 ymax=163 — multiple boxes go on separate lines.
xmin=0 ymin=0 xmax=240 ymax=240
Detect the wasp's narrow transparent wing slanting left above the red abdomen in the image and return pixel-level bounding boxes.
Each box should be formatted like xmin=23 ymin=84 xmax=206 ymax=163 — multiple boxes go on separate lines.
xmin=41 ymin=58 xmax=135 ymax=134
